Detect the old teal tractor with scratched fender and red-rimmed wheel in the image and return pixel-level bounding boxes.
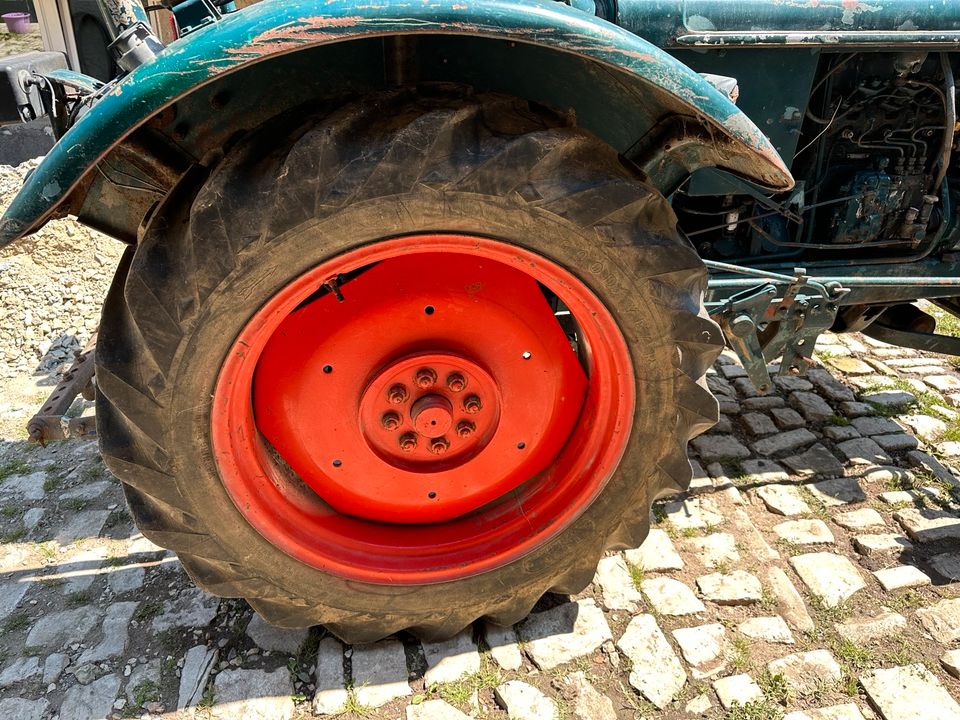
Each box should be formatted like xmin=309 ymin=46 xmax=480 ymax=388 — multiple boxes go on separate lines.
xmin=0 ymin=0 xmax=960 ymax=642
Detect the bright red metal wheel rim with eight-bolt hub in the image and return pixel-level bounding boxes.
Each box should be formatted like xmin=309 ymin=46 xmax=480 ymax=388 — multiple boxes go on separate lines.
xmin=211 ymin=235 xmax=636 ymax=584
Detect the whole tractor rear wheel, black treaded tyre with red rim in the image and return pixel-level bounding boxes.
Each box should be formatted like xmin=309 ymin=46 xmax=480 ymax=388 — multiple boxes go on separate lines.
xmin=97 ymin=87 xmax=721 ymax=642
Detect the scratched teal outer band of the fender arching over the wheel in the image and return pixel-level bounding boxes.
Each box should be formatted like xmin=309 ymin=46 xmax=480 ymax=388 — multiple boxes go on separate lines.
xmin=0 ymin=0 xmax=793 ymax=247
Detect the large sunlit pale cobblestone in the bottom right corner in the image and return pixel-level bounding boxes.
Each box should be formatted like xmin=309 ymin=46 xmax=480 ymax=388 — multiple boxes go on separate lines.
xmin=860 ymin=663 xmax=960 ymax=720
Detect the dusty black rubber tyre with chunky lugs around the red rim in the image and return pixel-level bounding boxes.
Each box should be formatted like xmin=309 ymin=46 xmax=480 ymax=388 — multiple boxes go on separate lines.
xmin=97 ymin=88 xmax=722 ymax=642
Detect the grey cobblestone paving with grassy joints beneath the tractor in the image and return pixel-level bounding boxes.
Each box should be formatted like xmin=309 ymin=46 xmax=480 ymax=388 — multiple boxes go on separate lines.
xmin=0 ymin=328 xmax=960 ymax=720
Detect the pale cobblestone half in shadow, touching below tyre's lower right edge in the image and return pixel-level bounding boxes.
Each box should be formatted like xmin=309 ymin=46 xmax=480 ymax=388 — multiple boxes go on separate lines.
xmin=520 ymin=599 xmax=613 ymax=670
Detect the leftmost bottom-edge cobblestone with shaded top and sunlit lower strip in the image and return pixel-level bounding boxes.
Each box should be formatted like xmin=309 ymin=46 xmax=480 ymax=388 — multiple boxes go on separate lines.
xmin=210 ymin=667 xmax=295 ymax=720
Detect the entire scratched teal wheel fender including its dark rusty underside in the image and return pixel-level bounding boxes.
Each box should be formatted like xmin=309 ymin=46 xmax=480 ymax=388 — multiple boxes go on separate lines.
xmin=0 ymin=0 xmax=793 ymax=247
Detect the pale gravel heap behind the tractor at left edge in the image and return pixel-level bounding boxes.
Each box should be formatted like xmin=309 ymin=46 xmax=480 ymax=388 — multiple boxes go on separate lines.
xmin=0 ymin=160 xmax=123 ymax=377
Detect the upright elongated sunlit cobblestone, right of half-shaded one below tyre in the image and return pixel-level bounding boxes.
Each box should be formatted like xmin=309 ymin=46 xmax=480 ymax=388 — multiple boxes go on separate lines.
xmin=617 ymin=615 xmax=687 ymax=709
